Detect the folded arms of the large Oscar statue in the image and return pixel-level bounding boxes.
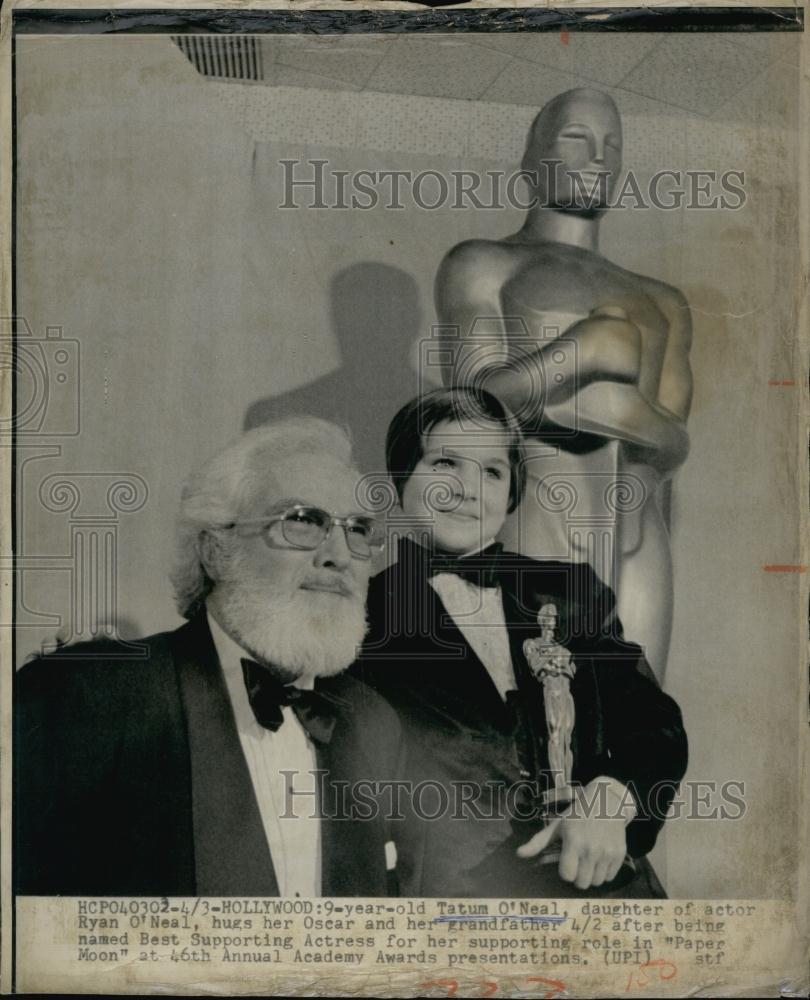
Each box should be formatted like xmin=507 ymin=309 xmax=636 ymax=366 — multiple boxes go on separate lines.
xmin=435 ymin=250 xmax=691 ymax=468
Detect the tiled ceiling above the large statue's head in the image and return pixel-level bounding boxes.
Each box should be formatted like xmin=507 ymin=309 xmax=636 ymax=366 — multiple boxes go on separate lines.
xmin=178 ymin=32 xmax=801 ymax=129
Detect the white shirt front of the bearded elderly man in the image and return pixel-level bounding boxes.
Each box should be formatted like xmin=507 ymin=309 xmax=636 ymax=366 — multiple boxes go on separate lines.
xmin=208 ymin=614 xmax=321 ymax=896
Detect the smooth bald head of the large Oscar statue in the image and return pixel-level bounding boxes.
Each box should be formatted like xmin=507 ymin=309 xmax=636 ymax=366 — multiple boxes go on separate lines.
xmin=522 ymin=87 xmax=622 ymax=213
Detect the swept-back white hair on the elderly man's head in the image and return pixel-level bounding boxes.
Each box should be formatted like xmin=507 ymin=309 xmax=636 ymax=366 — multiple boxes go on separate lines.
xmin=171 ymin=416 xmax=353 ymax=618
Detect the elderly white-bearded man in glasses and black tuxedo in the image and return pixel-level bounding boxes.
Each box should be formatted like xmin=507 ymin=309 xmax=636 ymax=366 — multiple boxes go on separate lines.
xmin=15 ymin=418 xmax=399 ymax=896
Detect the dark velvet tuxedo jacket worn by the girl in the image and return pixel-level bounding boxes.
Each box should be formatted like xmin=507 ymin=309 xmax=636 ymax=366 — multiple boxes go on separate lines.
xmin=354 ymin=542 xmax=687 ymax=896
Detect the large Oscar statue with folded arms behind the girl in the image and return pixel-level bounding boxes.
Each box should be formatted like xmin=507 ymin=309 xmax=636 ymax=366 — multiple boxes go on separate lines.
xmin=436 ymin=89 xmax=692 ymax=679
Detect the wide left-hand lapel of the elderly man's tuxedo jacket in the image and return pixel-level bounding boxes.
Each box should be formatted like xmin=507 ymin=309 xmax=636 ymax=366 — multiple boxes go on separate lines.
xmin=172 ymin=614 xmax=279 ymax=896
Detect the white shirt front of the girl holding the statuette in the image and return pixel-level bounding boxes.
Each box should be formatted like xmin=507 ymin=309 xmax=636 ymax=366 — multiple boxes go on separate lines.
xmin=430 ymin=553 xmax=517 ymax=701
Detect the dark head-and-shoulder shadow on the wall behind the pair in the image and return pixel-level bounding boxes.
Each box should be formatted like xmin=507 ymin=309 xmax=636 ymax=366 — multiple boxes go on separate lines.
xmin=244 ymin=262 xmax=421 ymax=472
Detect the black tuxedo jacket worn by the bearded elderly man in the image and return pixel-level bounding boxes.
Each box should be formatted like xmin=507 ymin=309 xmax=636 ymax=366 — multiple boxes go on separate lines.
xmin=14 ymin=615 xmax=401 ymax=896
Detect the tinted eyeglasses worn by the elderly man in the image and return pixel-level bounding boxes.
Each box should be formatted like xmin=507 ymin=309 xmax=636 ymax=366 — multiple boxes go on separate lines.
xmin=223 ymin=504 xmax=385 ymax=559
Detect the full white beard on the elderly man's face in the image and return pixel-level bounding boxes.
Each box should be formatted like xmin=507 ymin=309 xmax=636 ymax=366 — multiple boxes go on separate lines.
xmin=213 ymin=565 xmax=368 ymax=680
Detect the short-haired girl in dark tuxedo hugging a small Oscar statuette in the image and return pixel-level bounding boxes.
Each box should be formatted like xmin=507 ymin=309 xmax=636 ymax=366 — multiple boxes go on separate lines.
xmin=357 ymin=388 xmax=686 ymax=896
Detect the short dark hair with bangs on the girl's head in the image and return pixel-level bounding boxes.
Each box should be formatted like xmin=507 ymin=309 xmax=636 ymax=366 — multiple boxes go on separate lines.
xmin=385 ymin=386 xmax=526 ymax=514
